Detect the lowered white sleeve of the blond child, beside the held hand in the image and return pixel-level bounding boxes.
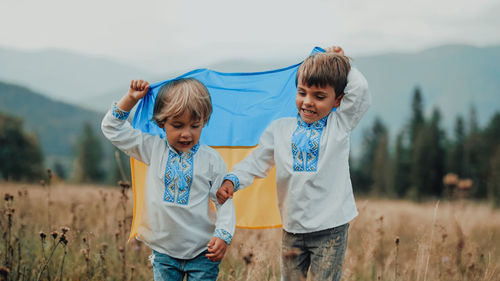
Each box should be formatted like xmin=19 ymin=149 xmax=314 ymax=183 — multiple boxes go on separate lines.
xmin=210 ymin=154 xmax=236 ymax=245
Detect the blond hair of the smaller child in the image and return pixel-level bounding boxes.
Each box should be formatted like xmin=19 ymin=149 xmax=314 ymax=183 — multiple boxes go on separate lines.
xmin=153 ymin=78 xmax=212 ymax=128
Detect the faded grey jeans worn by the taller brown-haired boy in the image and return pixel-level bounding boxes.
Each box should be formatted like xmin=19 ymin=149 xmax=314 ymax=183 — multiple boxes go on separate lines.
xmin=281 ymin=223 xmax=349 ymax=281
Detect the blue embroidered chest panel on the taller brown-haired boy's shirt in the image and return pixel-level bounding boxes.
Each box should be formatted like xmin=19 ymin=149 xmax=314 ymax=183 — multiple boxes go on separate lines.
xmin=292 ymin=115 xmax=328 ymax=172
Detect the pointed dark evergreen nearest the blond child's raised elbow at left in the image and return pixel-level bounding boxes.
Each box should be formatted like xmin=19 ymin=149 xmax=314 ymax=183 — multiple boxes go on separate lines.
xmin=76 ymin=123 xmax=104 ymax=182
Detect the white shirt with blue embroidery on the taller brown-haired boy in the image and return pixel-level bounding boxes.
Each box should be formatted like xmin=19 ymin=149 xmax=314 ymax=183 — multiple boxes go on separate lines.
xmin=225 ymin=68 xmax=371 ymax=233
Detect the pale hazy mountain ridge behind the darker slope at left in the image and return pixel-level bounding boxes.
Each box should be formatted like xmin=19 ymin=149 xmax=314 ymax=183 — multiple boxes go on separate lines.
xmin=0 ymin=47 xmax=153 ymax=105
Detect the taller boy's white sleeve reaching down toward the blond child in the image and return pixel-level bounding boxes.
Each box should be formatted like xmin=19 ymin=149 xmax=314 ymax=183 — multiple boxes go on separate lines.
xmin=224 ymin=121 xmax=276 ymax=190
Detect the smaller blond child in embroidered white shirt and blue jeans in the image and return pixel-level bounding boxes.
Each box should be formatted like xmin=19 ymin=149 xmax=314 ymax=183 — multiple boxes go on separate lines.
xmin=102 ymin=78 xmax=236 ymax=281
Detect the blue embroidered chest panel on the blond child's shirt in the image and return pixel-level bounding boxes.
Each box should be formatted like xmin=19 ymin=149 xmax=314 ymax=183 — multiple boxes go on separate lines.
xmin=163 ymin=143 xmax=200 ymax=205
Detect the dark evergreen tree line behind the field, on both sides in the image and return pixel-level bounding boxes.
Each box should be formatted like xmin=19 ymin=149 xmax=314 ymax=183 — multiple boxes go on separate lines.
xmin=0 ymin=87 xmax=500 ymax=206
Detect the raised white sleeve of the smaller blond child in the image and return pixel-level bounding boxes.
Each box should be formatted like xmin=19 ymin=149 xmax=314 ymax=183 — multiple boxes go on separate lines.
xmin=101 ymin=105 xmax=156 ymax=165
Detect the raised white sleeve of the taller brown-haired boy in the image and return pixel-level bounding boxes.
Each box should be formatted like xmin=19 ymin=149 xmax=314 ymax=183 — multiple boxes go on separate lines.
xmin=336 ymin=68 xmax=371 ymax=131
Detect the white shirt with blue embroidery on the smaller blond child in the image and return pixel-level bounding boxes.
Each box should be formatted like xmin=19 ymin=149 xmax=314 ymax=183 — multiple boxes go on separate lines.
xmin=101 ymin=106 xmax=236 ymax=259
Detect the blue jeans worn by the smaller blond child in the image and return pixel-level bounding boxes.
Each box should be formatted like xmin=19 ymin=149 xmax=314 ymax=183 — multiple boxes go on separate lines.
xmin=151 ymin=250 xmax=220 ymax=281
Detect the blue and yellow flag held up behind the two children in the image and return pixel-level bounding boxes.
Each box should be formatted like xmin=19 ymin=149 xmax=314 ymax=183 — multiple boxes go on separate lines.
xmin=130 ymin=47 xmax=324 ymax=238
